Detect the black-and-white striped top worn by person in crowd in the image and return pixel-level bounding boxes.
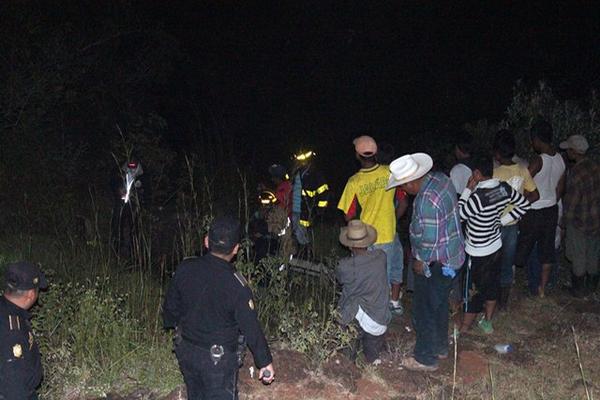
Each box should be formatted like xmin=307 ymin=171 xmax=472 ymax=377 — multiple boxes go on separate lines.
xmin=458 ymin=179 xmax=531 ymax=257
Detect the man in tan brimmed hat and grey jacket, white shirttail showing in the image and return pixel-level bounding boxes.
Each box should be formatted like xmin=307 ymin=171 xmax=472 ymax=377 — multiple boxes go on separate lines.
xmin=336 ymin=219 xmax=392 ymax=365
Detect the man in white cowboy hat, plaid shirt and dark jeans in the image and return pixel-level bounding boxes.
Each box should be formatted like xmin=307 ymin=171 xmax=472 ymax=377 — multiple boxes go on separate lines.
xmin=387 ymin=153 xmax=465 ymax=371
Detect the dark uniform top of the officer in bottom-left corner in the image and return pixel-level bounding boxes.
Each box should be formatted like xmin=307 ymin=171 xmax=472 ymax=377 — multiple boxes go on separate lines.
xmin=0 ymin=296 xmax=42 ymax=400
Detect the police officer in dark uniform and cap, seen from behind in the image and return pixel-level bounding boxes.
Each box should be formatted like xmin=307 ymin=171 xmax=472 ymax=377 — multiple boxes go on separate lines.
xmin=163 ymin=217 xmax=275 ymax=400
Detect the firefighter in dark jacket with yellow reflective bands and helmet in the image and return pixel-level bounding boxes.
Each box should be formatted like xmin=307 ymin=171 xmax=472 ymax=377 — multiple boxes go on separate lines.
xmin=292 ymin=150 xmax=329 ymax=245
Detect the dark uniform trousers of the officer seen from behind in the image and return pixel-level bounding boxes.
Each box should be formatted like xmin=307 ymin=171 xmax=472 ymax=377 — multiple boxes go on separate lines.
xmin=175 ymin=340 xmax=239 ymax=400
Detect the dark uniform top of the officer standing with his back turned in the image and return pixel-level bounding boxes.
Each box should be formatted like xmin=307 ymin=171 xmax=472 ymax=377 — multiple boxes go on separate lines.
xmin=163 ymin=254 xmax=272 ymax=368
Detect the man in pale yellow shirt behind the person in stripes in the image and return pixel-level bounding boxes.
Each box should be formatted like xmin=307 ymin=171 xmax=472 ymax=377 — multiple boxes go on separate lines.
xmin=494 ymin=130 xmax=540 ymax=309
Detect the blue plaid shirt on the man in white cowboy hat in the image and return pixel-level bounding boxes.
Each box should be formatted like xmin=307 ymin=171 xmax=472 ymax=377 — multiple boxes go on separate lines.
xmin=410 ymin=172 xmax=465 ymax=269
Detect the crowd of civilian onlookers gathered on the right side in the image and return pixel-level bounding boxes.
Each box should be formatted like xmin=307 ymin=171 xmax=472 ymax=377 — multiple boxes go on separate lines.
xmin=256 ymin=120 xmax=600 ymax=371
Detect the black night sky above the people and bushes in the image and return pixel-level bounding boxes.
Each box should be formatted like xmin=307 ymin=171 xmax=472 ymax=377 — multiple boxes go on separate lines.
xmin=0 ymin=0 xmax=600 ymax=197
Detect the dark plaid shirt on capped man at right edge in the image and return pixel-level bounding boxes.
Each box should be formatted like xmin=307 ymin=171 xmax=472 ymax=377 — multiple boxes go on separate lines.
xmin=564 ymin=158 xmax=600 ymax=233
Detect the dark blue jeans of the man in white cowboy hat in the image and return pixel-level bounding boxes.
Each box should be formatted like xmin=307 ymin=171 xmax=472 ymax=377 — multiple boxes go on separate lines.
xmin=412 ymin=263 xmax=452 ymax=366
